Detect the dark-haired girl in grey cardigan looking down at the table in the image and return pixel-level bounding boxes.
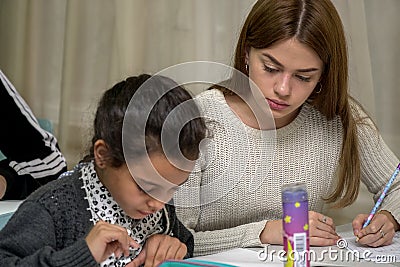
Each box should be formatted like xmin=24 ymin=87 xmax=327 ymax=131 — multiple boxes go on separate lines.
xmin=0 ymin=74 xmax=206 ymax=267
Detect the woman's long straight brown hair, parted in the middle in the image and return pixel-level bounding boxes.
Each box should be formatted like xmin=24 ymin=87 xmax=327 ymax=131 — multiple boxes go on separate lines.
xmin=227 ymin=0 xmax=361 ymax=207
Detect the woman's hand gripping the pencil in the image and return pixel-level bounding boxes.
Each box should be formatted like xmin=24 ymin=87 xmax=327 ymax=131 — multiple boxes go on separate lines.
xmin=353 ymin=210 xmax=399 ymax=247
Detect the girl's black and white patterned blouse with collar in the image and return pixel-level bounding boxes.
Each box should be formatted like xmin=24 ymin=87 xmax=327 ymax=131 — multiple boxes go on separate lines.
xmin=80 ymin=161 xmax=169 ymax=267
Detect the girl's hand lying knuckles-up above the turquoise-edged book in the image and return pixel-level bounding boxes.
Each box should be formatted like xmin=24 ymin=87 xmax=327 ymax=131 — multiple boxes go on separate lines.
xmin=127 ymin=234 xmax=187 ymax=267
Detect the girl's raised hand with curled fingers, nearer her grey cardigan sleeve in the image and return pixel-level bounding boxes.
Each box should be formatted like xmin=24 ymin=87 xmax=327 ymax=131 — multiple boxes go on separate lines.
xmin=85 ymin=221 xmax=139 ymax=263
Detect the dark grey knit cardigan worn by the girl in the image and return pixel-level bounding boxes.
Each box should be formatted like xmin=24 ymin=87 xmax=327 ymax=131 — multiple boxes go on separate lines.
xmin=0 ymin=164 xmax=193 ymax=267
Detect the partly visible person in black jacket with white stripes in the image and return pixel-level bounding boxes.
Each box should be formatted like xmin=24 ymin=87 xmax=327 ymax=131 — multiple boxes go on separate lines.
xmin=0 ymin=71 xmax=67 ymax=200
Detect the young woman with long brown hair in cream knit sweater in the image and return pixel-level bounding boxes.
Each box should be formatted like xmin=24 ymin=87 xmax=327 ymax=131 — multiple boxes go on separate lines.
xmin=175 ymin=0 xmax=400 ymax=255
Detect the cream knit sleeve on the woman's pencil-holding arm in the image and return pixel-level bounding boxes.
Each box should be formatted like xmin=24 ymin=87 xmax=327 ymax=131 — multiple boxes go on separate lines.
xmin=357 ymin=104 xmax=400 ymax=223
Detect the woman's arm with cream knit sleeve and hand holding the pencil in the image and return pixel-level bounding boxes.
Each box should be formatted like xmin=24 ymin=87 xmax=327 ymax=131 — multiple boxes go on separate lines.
xmin=353 ymin=107 xmax=400 ymax=247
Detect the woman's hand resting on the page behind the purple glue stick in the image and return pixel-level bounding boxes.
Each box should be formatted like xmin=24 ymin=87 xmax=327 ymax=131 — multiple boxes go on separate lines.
xmin=260 ymin=211 xmax=340 ymax=246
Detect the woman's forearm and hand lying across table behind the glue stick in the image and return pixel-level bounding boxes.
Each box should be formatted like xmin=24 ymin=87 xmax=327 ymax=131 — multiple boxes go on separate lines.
xmin=174 ymin=167 xmax=338 ymax=256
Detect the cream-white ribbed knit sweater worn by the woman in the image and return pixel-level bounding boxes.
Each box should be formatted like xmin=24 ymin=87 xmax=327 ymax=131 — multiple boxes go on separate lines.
xmin=174 ymin=90 xmax=400 ymax=255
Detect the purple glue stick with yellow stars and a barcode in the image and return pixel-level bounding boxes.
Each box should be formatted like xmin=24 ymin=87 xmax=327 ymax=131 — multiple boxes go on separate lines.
xmin=282 ymin=183 xmax=310 ymax=267
